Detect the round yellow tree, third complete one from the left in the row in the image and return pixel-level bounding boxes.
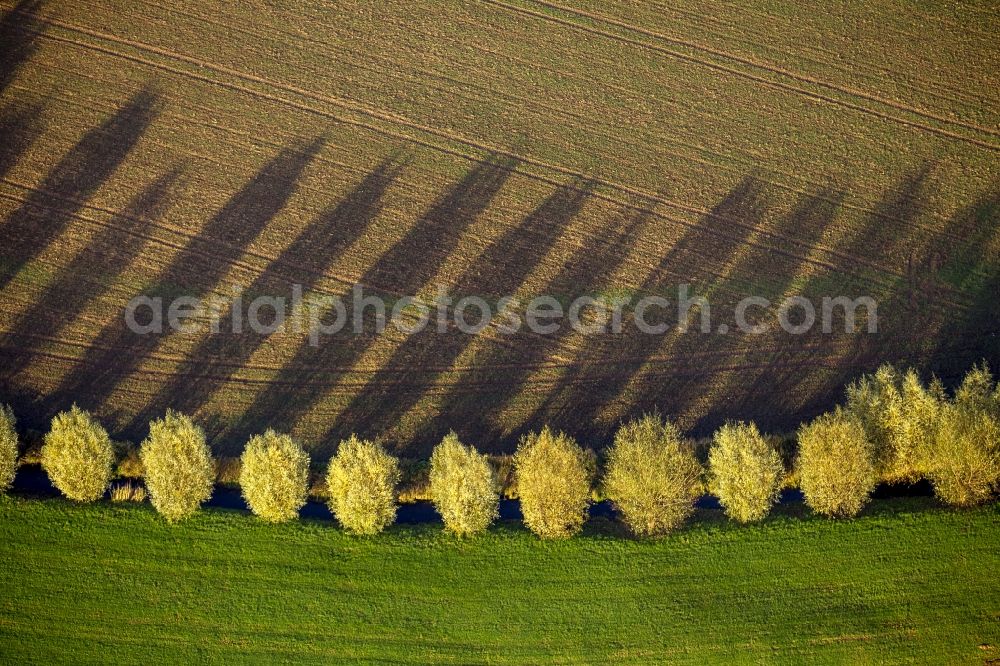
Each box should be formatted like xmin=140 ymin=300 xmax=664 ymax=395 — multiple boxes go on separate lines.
xmin=240 ymin=430 xmax=309 ymax=523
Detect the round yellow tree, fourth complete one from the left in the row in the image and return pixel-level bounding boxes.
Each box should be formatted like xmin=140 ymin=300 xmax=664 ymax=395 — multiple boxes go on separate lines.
xmin=326 ymin=435 xmax=401 ymax=534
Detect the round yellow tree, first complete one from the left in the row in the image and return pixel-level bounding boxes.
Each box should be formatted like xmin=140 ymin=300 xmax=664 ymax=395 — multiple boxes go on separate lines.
xmin=42 ymin=405 xmax=115 ymax=502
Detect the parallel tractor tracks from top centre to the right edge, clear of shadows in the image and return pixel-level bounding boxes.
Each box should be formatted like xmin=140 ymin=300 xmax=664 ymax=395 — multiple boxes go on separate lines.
xmin=498 ymin=0 xmax=1000 ymax=143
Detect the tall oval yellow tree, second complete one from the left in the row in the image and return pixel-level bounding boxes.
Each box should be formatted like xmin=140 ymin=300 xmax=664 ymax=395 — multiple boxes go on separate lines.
xmin=139 ymin=410 xmax=215 ymax=522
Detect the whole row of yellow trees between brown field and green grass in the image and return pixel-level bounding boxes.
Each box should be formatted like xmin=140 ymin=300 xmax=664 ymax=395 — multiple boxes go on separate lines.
xmin=0 ymin=366 xmax=1000 ymax=538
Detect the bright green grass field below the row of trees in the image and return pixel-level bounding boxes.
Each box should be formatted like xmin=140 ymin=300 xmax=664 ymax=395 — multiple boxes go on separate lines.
xmin=0 ymin=497 xmax=1000 ymax=664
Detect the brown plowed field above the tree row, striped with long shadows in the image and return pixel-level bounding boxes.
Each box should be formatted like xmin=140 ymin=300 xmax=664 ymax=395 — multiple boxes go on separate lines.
xmin=0 ymin=0 xmax=1000 ymax=457
